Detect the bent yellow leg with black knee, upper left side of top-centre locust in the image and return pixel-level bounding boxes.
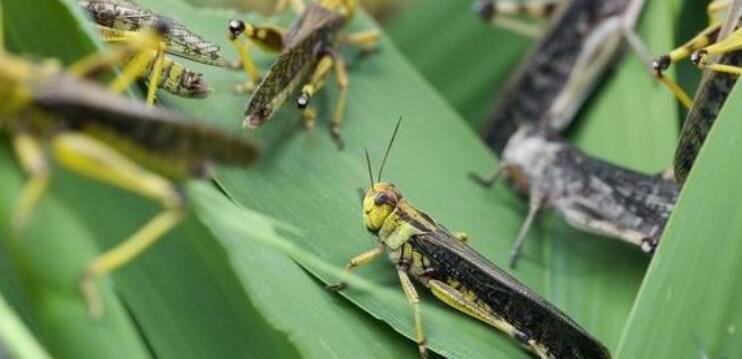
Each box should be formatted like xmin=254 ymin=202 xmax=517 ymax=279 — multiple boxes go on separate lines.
xmin=229 ymin=20 xmax=283 ymax=92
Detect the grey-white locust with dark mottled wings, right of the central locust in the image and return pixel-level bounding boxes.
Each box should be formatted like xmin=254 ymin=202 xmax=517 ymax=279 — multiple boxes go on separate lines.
xmin=475 ymin=124 xmax=679 ymax=267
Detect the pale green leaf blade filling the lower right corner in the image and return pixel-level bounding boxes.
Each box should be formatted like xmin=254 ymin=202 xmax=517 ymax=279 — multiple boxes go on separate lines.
xmin=617 ymin=86 xmax=742 ymax=358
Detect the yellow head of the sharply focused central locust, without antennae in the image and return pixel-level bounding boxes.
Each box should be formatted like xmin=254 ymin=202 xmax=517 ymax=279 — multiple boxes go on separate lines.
xmin=363 ymin=182 xmax=402 ymax=233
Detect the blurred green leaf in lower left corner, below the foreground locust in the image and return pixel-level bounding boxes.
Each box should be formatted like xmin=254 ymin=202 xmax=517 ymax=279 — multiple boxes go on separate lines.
xmin=0 ymin=145 xmax=147 ymax=358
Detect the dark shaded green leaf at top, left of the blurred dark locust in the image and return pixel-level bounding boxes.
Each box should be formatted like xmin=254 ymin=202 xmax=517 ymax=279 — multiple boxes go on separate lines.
xmin=388 ymin=0 xmax=533 ymax=129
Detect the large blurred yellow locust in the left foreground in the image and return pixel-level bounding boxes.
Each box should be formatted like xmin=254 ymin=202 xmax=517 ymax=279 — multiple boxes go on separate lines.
xmin=0 ymin=19 xmax=258 ymax=316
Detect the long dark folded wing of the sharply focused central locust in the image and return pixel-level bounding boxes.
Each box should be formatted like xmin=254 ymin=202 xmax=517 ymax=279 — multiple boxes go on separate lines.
xmin=410 ymin=229 xmax=610 ymax=358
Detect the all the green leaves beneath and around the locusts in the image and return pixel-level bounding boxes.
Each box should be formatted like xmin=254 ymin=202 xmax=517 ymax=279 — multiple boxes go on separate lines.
xmin=0 ymin=0 xmax=742 ymax=358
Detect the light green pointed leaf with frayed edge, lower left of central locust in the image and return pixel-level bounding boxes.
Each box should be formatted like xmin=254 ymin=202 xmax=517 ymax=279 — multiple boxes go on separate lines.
xmin=189 ymin=185 xmax=424 ymax=358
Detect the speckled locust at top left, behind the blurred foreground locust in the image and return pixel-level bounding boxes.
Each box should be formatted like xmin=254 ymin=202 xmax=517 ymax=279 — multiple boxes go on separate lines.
xmin=78 ymin=0 xmax=230 ymax=104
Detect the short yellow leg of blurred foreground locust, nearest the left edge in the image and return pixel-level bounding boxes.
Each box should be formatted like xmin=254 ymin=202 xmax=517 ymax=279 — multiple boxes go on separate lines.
xmin=11 ymin=132 xmax=50 ymax=232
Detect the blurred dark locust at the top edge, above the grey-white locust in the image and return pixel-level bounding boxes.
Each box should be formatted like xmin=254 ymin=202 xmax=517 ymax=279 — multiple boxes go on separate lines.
xmin=476 ymin=0 xmax=650 ymax=155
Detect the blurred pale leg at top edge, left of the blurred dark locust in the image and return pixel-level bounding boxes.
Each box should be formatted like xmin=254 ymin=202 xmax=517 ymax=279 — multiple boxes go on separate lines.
xmin=474 ymin=0 xmax=563 ymax=38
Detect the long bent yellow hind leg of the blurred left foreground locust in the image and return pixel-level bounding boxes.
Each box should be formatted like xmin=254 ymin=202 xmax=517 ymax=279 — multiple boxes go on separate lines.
xmin=52 ymin=133 xmax=185 ymax=316
